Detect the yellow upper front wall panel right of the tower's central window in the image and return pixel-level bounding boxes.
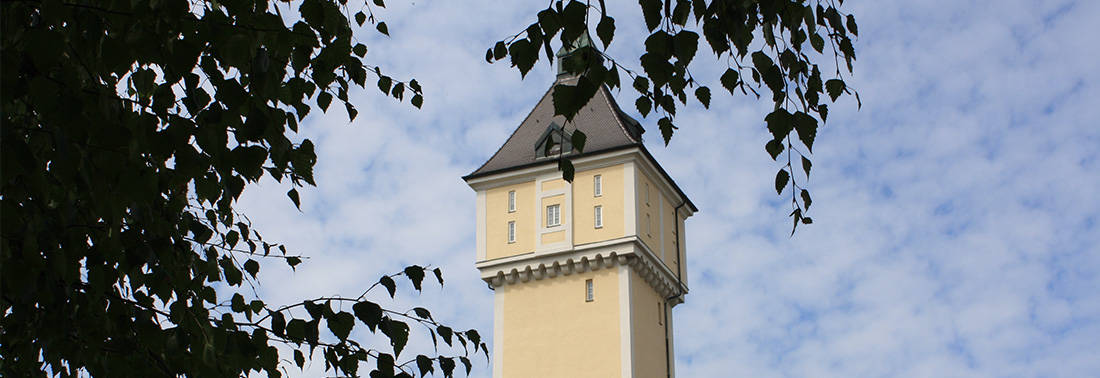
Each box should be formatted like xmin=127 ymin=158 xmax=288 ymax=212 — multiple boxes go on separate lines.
xmin=573 ymin=164 xmax=626 ymax=245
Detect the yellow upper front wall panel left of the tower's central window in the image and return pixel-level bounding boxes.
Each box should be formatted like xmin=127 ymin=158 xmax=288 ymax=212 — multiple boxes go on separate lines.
xmin=485 ymin=180 xmax=538 ymax=260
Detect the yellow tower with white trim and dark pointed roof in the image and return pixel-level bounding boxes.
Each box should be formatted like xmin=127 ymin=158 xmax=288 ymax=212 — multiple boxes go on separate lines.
xmin=463 ymin=42 xmax=697 ymax=378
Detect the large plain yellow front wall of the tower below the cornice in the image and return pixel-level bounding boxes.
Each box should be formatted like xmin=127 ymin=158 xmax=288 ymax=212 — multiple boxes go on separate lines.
xmin=494 ymin=269 xmax=622 ymax=378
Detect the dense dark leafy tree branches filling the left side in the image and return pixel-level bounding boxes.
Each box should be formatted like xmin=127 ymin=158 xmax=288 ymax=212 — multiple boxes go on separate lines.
xmin=0 ymin=0 xmax=477 ymax=377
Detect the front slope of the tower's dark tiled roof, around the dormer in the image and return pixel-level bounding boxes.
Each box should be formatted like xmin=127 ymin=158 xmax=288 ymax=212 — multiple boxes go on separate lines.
xmin=465 ymin=82 xmax=645 ymax=179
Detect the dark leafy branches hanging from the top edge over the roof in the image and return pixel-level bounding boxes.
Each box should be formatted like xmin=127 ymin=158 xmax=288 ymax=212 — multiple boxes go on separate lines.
xmin=485 ymin=0 xmax=860 ymax=234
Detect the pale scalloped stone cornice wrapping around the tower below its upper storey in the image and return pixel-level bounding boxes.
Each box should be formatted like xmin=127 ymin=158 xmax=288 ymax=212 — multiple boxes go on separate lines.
xmin=477 ymin=236 xmax=688 ymax=305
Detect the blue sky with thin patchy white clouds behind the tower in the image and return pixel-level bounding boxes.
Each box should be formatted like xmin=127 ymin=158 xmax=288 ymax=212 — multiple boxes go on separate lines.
xmin=239 ymin=0 xmax=1100 ymax=377
